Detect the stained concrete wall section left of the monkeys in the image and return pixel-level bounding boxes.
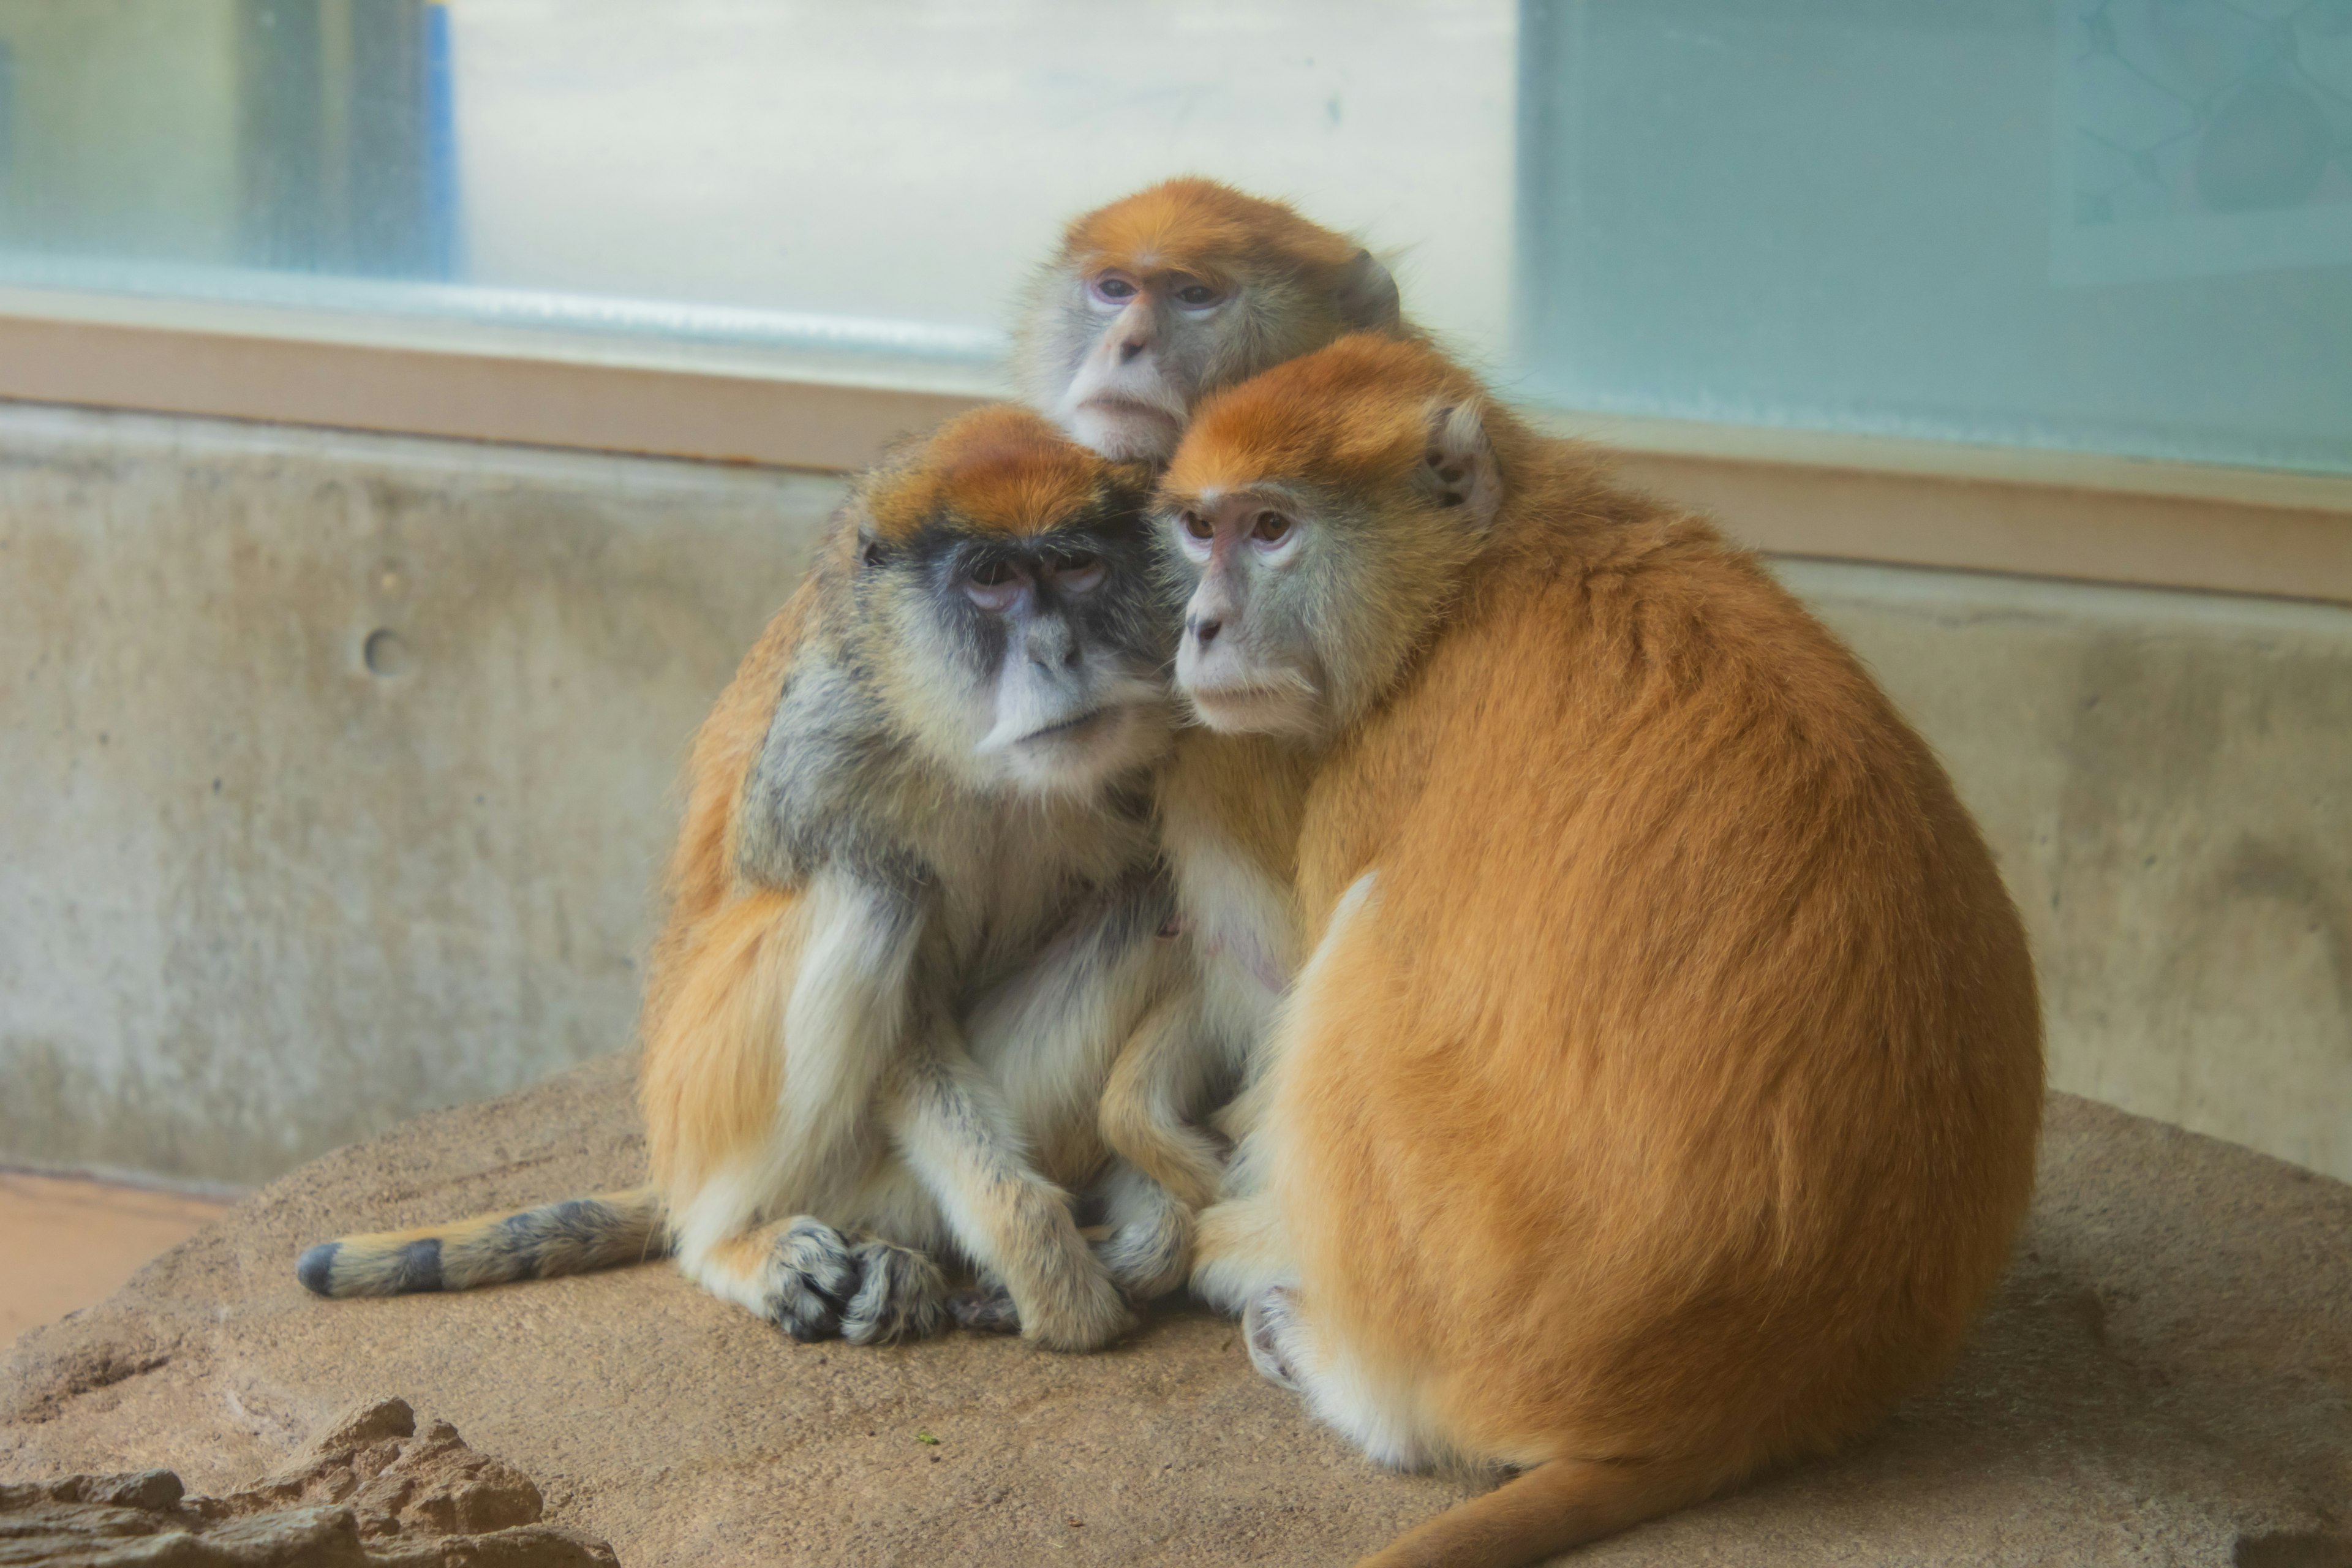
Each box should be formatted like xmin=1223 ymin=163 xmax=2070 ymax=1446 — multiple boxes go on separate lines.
xmin=0 ymin=404 xmax=840 ymax=1183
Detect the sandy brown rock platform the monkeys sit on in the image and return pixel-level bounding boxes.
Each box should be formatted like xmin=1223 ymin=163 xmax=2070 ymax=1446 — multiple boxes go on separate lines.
xmin=0 ymin=1058 xmax=2352 ymax=1568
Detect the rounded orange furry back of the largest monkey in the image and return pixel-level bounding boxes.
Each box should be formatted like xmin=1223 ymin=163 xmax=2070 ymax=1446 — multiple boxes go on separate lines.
xmin=1284 ymin=494 xmax=2041 ymax=1479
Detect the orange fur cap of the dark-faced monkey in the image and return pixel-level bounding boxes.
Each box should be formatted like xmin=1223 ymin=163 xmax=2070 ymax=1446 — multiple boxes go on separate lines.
xmin=865 ymin=402 xmax=1120 ymax=543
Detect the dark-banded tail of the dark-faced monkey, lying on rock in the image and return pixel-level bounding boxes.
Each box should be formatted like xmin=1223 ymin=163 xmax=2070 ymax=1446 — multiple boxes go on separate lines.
xmin=294 ymin=1187 xmax=670 ymax=1295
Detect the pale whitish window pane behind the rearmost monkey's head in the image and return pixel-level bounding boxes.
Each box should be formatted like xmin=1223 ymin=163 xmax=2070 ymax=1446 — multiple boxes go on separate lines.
xmin=0 ymin=0 xmax=1517 ymax=362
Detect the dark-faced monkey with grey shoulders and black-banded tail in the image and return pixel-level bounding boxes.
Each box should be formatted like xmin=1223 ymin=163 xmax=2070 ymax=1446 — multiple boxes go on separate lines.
xmin=299 ymin=407 xmax=1174 ymax=1349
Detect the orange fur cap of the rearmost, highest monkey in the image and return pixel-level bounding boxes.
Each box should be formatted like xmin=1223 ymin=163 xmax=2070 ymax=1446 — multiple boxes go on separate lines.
xmin=1061 ymin=176 xmax=1357 ymax=280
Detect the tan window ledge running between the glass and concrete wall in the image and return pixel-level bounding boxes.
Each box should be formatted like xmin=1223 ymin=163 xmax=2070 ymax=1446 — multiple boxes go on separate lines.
xmin=0 ymin=287 xmax=2352 ymax=604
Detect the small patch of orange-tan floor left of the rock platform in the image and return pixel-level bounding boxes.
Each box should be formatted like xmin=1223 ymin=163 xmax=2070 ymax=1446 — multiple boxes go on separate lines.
xmin=0 ymin=1170 xmax=228 ymax=1344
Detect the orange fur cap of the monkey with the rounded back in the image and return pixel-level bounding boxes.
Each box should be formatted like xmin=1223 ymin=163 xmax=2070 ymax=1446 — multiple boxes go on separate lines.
xmin=1162 ymin=331 xmax=1482 ymax=496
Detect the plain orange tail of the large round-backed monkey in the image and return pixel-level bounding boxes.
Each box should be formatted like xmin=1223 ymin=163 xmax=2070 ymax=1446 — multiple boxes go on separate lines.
xmin=1357 ymin=1460 xmax=1728 ymax=1568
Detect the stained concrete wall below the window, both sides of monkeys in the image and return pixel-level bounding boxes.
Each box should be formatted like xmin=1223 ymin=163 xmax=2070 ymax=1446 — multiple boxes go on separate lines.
xmin=0 ymin=404 xmax=2352 ymax=1183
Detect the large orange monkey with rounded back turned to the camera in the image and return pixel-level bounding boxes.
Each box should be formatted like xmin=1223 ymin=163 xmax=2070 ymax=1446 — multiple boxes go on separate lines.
xmin=1106 ymin=336 xmax=2041 ymax=1568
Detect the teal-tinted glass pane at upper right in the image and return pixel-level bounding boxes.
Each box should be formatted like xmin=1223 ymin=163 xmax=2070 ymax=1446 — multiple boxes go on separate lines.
xmin=1520 ymin=0 xmax=2352 ymax=472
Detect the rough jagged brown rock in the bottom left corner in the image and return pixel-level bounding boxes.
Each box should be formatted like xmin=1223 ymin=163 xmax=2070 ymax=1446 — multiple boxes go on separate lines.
xmin=0 ymin=1399 xmax=614 ymax=1568
